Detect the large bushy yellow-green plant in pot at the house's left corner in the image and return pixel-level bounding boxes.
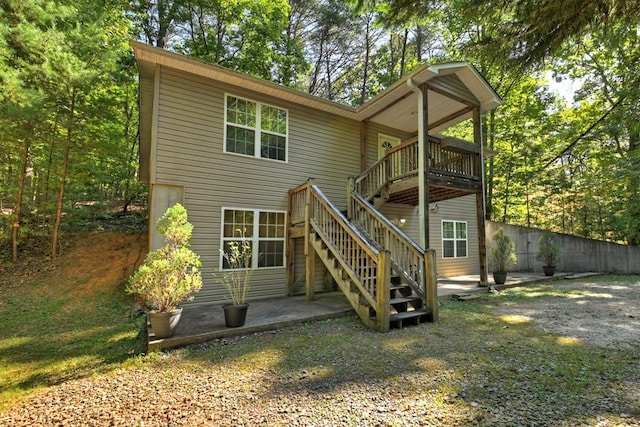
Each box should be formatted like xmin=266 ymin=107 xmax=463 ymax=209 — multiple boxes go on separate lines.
xmin=126 ymin=203 xmax=202 ymax=338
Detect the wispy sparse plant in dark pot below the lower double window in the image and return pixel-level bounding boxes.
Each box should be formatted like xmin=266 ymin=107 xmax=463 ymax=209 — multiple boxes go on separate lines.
xmin=214 ymin=234 xmax=253 ymax=328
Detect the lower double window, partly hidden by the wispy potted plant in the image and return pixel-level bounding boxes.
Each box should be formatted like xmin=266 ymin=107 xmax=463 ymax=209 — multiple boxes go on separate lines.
xmin=221 ymin=209 xmax=285 ymax=269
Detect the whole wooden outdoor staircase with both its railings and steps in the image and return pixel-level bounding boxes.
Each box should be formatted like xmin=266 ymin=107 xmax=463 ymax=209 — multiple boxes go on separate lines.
xmin=289 ymin=180 xmax=437 ymax=332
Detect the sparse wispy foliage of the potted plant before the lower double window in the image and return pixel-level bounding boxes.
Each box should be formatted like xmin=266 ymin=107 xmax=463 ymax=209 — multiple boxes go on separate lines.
xmin=214 ymin=230 xmax=253 ymax=305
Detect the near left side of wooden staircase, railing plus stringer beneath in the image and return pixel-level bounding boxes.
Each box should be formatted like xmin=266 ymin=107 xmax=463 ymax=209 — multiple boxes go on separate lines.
xmin=289 ymin=181 xmax=391 ymax=332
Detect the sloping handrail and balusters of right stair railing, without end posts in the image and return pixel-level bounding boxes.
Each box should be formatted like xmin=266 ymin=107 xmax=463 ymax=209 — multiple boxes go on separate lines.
xmin=348 ymin=191 xmax=427 ymax=302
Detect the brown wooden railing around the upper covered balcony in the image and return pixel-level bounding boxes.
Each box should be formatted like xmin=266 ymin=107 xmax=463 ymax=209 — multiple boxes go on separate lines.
xmin=354 ymin=136 xmax=480 ymax=200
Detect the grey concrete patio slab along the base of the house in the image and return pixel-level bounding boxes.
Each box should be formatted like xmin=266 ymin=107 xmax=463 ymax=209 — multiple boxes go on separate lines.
xmin=147 ymin=273 xmax=597 ymax=351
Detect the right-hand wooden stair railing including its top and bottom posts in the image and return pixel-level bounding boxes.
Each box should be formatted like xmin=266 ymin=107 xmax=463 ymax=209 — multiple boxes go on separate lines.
xmin=347 ymin=186 xmax=438 ymax=321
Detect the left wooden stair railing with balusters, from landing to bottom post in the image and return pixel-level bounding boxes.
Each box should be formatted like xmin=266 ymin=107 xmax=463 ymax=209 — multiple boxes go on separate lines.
xmin=289 ymin=181 xmax=390 ymax=329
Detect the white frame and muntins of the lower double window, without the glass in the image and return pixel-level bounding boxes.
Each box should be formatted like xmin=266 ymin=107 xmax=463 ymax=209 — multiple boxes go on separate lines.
xmin=218 ymin=206 xmax=287 ymax=271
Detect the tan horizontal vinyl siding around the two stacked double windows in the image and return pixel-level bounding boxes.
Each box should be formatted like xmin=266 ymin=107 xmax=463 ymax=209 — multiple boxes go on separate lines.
xmin=151 ymin=69 xmax=360 ymax=304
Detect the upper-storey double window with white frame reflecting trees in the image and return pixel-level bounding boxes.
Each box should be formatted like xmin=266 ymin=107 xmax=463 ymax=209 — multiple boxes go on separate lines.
xmin=224 ymin=95 xmax=288 ymax=162
